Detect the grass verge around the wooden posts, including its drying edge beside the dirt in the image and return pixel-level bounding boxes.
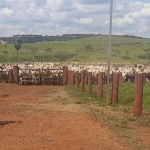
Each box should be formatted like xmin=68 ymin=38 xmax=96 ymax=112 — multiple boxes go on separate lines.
xmin=66 ymin=83 xmax=150 ymax=126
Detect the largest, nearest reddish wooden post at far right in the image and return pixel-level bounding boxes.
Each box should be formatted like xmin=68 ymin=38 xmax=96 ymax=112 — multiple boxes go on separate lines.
xmin=133 ymin=73 xmax=143 ymax=116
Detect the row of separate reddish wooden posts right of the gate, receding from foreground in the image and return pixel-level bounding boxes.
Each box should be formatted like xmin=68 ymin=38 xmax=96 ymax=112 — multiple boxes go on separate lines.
xmin=65 ymin=71 xmax=145 ymax=116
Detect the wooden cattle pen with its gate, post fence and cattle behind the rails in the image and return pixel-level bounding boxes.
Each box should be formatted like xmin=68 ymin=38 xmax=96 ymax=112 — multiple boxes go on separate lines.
xmin=0 ymin=62 xmax=149 ymax=116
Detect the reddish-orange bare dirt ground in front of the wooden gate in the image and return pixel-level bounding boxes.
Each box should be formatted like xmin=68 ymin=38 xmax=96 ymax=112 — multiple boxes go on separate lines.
xmin=0 ymin=84 xmax=141 ymax=150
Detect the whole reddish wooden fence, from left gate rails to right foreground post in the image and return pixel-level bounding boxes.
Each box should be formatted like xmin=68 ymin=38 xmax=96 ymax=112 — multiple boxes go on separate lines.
xmin=0 ymin=66 xmax=146 ymax=116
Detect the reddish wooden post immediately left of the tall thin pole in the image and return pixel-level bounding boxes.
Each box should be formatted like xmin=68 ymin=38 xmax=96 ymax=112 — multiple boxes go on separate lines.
xmin=97 ymin=72 xmax=103 ymax=97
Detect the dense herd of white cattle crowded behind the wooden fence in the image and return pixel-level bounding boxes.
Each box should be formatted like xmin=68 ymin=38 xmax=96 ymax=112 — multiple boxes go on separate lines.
xmin=0 ymin=62 xmax=150 ymax=82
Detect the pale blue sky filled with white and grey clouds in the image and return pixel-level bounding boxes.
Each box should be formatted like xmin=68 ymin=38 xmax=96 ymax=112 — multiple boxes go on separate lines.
xmin=0 ymin=0 xmax=150 ymax=38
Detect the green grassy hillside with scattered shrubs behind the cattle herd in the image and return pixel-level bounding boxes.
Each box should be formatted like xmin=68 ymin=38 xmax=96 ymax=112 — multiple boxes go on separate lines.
xmin=0 ymin=36 xmax=150 ymax=63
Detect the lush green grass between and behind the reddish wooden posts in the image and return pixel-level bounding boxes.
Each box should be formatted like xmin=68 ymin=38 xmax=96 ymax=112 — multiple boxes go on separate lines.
xmin=66 ymin=83 xmax=150 ymax=110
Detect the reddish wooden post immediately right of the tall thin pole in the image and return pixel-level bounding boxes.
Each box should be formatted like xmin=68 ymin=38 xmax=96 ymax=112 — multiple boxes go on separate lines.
xmin=111 ymin=73 xmax=119 ymax=103
